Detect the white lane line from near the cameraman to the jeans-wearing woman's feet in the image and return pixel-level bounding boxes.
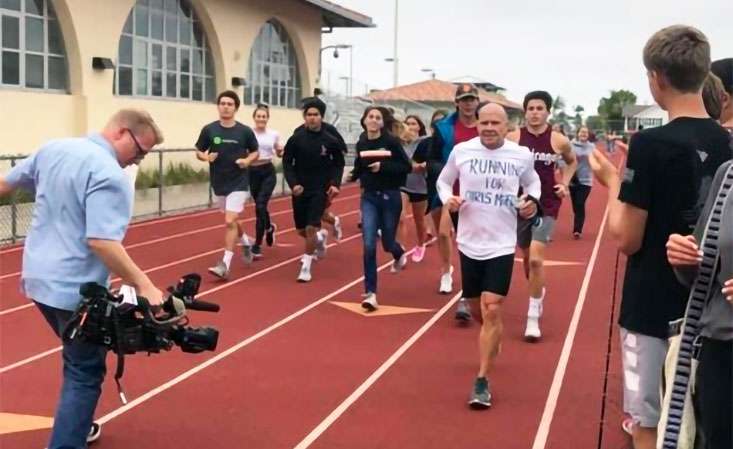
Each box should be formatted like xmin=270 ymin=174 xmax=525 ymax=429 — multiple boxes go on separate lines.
xmin=97 ymin=261 xmax=392 ymax=424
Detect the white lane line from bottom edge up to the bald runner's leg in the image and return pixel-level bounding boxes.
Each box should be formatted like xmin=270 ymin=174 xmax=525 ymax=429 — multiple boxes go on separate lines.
xmin=294 ymin=292 xmax=462 ymax=449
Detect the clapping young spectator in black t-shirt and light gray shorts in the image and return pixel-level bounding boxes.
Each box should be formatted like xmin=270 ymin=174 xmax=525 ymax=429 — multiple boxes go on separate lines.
xmin=591 ymin=26 xmax=731 ymax=449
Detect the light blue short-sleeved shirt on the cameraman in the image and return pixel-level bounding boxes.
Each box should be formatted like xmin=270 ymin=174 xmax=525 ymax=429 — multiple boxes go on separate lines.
xmin=6 ymin=134 xmax=133 ymax=310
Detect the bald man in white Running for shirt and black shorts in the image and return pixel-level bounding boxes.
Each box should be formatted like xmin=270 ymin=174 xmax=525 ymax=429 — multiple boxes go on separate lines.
xmin=437 ymin=104 xmax=541 ymax=409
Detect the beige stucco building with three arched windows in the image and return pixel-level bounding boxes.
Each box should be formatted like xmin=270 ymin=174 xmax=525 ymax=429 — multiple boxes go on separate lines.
xmin=0 ymin=0 xmax=372 ymax=155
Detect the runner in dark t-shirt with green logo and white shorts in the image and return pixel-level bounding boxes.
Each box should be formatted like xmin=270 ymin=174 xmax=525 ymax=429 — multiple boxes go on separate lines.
xmin=196 ymin=91 xmax=257 ymax=279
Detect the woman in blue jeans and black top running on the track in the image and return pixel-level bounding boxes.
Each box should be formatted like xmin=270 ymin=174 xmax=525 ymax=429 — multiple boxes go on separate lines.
xmin=352 ymin=106 xmax=412 ymax=311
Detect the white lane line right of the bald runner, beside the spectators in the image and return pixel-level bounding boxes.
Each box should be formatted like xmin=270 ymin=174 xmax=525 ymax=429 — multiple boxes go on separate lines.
xmin=532 ymin=206 xmax=608 ymax=449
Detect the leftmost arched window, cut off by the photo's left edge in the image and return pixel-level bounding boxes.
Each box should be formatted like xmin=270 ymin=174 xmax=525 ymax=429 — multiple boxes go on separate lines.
xmin=0 ymin=0 xmax=67 ymax=90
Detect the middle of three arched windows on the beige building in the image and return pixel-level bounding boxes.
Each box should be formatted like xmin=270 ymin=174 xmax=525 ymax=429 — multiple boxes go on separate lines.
xmin=116 ymin=0 xmax=216 ymax=101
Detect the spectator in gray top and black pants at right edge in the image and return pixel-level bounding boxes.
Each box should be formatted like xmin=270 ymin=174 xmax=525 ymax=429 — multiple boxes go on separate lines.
xmin=667 ymin=158 xmax=733 ymax=449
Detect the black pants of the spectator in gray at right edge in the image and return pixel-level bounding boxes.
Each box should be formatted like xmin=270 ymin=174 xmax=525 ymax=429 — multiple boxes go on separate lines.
xmin=693 ymin=338 xmax=733 ymax=449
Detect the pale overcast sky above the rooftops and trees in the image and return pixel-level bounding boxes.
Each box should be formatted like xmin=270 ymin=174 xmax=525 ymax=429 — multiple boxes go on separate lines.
xmin=323 ymin=0 xmax=733 ymax=114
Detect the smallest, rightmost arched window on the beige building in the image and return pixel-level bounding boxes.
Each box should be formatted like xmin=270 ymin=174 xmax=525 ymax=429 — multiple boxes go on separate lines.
xmin=244 ymin=20 xmax=301 ymax=108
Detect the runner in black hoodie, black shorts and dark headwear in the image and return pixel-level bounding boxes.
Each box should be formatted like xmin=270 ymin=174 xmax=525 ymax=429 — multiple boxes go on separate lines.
xmin=283 ymin=101 xmax=345 ymax=282
